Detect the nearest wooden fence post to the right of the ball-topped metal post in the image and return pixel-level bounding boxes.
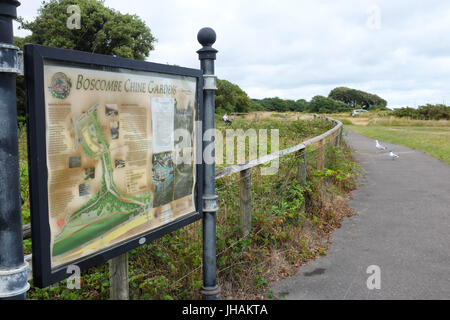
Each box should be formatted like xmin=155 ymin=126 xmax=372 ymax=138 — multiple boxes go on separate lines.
xmin=239 ymin=168 xmax=252 ymax=237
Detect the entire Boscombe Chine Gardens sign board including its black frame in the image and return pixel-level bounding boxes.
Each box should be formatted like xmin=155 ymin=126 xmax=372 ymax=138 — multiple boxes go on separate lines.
xmin=26 ymin=45 xmax=201 ymax=285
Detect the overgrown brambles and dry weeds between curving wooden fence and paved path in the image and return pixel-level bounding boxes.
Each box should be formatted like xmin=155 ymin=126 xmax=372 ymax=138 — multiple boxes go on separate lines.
xmin=214 ymin=141 xmax=357 ymax=299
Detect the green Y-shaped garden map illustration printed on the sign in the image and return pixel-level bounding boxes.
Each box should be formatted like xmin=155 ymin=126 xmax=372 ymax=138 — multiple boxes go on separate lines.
xmin=52 ymin=104 xmax=152 ymax=256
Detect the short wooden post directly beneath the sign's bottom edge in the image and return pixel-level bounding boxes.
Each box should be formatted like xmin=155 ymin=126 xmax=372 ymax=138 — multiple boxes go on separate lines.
xmin=109 ymin=253 xmax=130 ymax=300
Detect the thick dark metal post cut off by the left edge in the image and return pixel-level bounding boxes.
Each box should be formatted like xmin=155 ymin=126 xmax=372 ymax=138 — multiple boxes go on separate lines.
xmin=0 ymin=0 xmax=30 ymax=300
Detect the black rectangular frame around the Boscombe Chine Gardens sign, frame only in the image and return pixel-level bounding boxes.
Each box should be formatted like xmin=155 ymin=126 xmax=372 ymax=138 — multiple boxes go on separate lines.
xmin=25 ymin=44 xmax=204 ymax=288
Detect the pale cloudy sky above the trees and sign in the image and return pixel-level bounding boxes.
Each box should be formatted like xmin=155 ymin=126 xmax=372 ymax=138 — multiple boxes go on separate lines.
xmin=15 ymin=0 xmax=450 ymax=107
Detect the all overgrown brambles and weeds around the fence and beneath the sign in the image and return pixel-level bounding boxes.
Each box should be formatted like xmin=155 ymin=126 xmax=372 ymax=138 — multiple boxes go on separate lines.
xmin=20 ymin=119 xmax=357 ymax=299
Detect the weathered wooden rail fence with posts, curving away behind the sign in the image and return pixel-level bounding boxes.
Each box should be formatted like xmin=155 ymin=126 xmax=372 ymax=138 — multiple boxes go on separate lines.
xmin=23 ymin=115 xmax=343 ymax=300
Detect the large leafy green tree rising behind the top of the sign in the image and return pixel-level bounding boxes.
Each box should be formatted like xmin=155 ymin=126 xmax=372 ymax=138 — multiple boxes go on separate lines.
xmin=14 ymin=0 xmax=157 ymax=116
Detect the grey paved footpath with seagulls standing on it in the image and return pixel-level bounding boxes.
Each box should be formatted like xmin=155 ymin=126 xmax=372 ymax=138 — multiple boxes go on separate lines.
xmin=271 ymin=131 xmax=450 ymax=300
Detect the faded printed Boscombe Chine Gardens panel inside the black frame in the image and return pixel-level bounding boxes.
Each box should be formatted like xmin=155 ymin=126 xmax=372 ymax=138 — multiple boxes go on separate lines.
xmin=44 ymin=63 xmax=196 ymax=268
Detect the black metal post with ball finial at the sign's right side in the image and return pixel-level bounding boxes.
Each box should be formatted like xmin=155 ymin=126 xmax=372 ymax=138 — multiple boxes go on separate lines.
xmin=197 ymin=28 xmax=220 ymax=300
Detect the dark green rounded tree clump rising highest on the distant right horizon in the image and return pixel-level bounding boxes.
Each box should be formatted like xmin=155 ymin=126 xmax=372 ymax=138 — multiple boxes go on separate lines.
xmin=328 ymin=87 xmax=387 ymax=110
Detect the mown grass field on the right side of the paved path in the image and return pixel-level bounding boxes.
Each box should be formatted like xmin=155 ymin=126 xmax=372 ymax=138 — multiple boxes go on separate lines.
xmin=336 ymin=117 xmax=450 ymax=164
